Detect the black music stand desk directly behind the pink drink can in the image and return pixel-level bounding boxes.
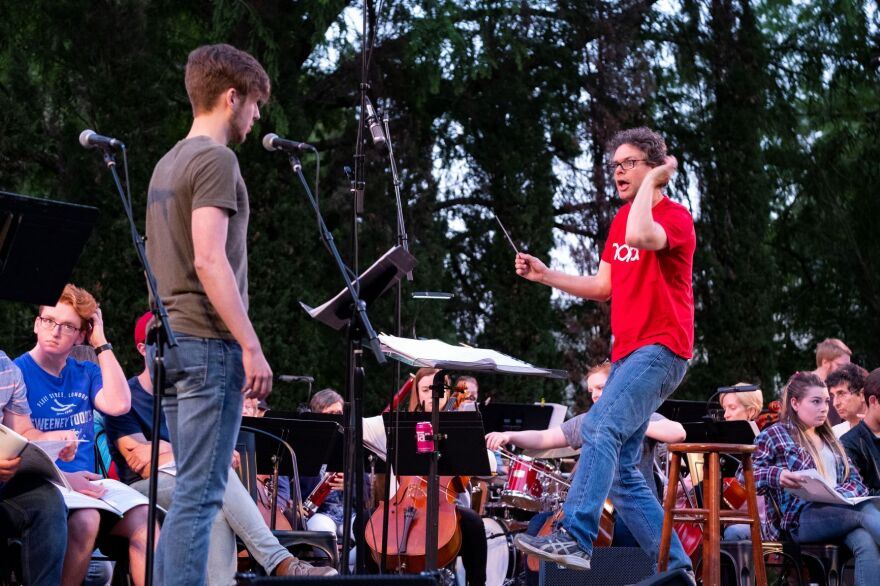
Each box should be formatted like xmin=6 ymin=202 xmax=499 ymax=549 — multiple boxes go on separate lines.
xmin=382 ymin=411 xmax=492 ymax=476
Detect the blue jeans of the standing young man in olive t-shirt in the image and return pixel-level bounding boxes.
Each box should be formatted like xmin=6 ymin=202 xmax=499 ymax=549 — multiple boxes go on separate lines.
xmin=149 ymin=335 xmax=244 ymax=586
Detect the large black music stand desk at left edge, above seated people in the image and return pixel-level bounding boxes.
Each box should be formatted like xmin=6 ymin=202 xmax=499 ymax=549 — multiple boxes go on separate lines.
xmin=0 ymin=191 xmax=98 ymax=305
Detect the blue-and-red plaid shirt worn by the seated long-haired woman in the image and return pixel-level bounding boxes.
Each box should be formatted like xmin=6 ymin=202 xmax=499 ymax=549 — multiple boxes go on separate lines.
xmin=752 ymin=423 xmax=868 ymax=540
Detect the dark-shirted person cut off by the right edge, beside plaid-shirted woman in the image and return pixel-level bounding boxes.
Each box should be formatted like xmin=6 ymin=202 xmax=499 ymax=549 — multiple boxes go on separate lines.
xmin=840 ymin=368 xmax=880 ymax=496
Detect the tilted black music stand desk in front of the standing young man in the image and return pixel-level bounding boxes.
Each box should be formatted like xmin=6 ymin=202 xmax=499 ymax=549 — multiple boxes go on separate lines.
xmin=299 ymin=246 xmax=416 ymax=330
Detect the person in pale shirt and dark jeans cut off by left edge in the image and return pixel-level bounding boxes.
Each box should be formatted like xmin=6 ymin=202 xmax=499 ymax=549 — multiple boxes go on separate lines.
xmin=0 ymin=351 xmax=76 ymax=586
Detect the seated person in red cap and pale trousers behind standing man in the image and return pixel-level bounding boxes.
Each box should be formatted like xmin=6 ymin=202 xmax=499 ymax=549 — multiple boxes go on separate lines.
xmin=105 ymin=313 xmax=336 ymax=586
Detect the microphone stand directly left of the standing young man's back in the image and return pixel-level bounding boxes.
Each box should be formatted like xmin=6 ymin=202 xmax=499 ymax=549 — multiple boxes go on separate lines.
xmin=95 ymin=146 xmax=177 ymax=586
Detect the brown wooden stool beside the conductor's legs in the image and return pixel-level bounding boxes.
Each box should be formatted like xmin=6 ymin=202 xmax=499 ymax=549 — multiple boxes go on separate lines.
xmin=657 ymin=444 xmax=767 ymax=586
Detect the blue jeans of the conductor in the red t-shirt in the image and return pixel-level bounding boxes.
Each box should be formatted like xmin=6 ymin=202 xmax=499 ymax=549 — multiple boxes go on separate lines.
xmin=563 ymin=344 xmax=691 ymax=570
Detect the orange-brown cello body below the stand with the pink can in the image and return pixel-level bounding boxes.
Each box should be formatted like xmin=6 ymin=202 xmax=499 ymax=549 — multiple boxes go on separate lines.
xmin=365 ymin=476 xmax=470 ymax=574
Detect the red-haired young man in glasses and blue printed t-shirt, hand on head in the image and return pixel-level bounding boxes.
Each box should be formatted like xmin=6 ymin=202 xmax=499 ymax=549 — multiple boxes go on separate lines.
xmin=15 ymin=284 xmax=147 ymax=586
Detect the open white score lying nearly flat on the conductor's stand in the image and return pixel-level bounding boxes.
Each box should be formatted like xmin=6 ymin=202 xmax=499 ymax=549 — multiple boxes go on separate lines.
xmin=379 ymin=334 xmax=568 ymax=378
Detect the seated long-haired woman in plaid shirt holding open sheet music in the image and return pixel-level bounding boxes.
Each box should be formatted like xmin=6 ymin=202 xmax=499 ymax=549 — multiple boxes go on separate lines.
xmin=754 ymin=372 xmax=880 ymax=586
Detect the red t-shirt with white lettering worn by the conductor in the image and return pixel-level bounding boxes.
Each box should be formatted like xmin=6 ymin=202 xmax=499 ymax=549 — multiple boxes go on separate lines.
xmin=602 ymin=196 xmax=697 ymax=361
